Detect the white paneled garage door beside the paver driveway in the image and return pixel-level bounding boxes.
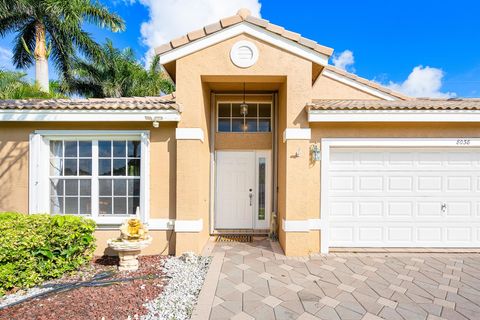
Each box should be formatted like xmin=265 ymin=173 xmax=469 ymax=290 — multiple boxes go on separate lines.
xmin=327 ymin=148 xmax=480 ymax=247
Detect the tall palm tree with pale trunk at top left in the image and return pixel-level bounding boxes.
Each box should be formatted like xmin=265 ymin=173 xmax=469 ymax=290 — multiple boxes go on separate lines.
xmin=0 ymin=0 xmax=125 ymax=92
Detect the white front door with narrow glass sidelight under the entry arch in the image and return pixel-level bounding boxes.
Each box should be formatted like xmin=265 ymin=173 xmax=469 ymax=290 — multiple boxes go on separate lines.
xmin=215 ymin=151 xmax=271 ymax=229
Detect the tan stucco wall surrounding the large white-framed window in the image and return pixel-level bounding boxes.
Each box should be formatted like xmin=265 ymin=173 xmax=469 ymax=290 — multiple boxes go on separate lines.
xmin=0 ymin=122 xmax=176 ymax=254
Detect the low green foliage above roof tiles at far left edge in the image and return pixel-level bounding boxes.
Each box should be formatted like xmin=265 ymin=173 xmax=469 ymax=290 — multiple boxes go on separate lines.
xmin=0 ymin=70 xmax=65 ymax=99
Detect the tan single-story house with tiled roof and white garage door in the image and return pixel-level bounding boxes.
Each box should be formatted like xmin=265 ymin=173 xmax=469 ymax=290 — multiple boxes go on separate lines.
xmin=0 ymin=9 xmax=480 ymax=255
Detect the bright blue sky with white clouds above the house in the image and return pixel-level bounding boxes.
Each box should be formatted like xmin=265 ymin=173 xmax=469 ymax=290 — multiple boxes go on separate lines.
xmin=0 ymin=0 xmax=480 ymax=98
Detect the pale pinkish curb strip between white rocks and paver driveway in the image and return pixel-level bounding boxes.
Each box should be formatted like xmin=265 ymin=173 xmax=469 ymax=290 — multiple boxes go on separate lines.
xmin=190 ymin=251 xmax=225 ymax=320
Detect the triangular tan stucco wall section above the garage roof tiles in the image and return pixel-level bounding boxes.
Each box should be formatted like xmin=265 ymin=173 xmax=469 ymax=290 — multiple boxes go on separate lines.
xmin=312 ymin=75 xmax=379 ymax=100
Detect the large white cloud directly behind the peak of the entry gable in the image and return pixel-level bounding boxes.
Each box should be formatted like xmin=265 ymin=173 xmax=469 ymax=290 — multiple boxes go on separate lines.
xmin=135 ymin=0 xmax=261 ymax=63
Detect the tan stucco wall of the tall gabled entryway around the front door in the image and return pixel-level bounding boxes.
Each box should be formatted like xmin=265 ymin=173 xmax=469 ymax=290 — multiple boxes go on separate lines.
xmin=172 ymin=35 xmax=312 ymax=255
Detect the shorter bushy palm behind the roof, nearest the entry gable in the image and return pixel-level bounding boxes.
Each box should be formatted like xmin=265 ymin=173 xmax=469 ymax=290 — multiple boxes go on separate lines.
xmin=62 ymin=39 xmax=174 ymax=98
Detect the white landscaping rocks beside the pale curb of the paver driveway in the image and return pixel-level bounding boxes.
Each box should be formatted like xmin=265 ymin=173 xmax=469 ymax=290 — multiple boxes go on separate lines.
xmin=141 ymin=253 xmax=211 ymax=320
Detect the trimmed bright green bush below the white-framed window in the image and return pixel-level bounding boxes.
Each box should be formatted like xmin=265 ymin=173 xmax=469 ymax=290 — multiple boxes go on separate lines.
xmin=0 ymin=212 xmax=95 ymax=296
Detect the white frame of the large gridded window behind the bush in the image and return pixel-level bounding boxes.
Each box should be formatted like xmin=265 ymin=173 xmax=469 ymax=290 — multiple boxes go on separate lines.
xmin=29 ymin=130 xmax=150 ymax=225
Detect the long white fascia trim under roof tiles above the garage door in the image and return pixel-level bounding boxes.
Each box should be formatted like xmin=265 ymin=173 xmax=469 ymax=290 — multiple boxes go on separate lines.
xmin=308 ymin=110 xmax=480 ymax=122
